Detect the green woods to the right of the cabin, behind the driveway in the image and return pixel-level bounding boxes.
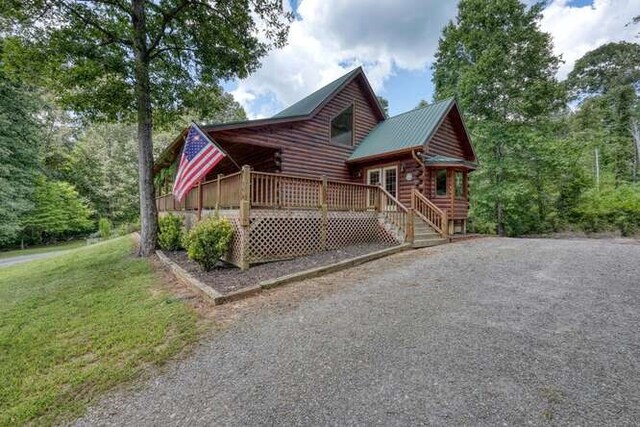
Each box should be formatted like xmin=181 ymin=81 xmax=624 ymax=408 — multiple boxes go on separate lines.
xmin=432 ymin=0 xmax=640 ymax=236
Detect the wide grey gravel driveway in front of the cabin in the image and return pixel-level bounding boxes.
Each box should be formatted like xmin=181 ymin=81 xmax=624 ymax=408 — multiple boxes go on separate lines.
xmin=78 ymin=238 xmax=640 ymax=425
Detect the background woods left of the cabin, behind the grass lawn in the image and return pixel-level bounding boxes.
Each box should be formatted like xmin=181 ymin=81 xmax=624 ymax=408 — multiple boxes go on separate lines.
xmin=0 ymin=58 xmax=246 ymax=248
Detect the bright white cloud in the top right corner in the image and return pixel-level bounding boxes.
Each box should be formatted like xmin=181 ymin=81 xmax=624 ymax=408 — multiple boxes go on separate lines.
xmin=541 ymin=0 xmax=640 ymax=79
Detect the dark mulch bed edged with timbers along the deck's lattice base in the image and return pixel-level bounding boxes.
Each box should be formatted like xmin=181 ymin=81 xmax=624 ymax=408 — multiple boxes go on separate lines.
xmin=165 ymin=243 xmax=389 ymax=295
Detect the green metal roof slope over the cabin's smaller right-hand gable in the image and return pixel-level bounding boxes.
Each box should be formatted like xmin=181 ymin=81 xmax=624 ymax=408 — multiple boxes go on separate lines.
xmin=349 ymin=98 xmax=454 ymax=161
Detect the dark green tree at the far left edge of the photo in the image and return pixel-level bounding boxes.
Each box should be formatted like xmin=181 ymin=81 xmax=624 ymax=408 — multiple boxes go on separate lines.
xmin=0 ymin=51 xmax=41 ymax=247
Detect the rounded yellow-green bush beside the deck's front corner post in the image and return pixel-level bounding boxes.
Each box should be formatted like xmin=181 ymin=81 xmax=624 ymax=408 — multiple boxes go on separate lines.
xmin=183 ymin=218 xmax=233 ymax=271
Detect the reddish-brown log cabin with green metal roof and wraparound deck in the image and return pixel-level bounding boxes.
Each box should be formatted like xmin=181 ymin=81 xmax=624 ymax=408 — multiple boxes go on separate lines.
xmin=154 ymin=68 xmax=477 ymax=268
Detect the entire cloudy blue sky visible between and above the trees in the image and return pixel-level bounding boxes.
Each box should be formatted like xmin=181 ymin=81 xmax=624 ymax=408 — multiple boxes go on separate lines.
xmin=224 ymin=0 xmax=640 ymax=119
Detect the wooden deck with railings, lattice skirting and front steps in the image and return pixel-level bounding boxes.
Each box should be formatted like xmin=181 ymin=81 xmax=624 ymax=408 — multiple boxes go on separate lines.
xmin=156 ymin=166 xmax=448 ymax=268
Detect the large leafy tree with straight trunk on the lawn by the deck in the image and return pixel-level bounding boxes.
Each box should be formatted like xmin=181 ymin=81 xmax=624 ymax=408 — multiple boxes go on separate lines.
xmin=0 ymin=0 xmax=292 ymax=256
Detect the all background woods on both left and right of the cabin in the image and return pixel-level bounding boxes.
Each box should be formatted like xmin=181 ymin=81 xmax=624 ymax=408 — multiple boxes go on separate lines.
xmin=0 ymin=0 xmax=640 ymax=248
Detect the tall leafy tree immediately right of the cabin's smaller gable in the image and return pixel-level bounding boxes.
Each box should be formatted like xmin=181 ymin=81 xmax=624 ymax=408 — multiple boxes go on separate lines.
xmin=433 ymin=0 xmax=563 ymax=235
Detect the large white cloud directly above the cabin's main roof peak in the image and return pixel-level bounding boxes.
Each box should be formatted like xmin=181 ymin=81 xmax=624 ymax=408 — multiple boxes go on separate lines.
xmin=232 ymin=0 xmax=455 ymax=118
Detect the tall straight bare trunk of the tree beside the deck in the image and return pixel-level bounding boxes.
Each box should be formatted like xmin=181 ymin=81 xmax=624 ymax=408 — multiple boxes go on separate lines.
xmin=132 ymin=0 xmax=158 ymax=256
